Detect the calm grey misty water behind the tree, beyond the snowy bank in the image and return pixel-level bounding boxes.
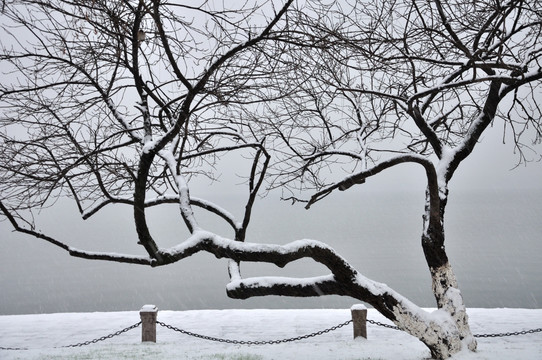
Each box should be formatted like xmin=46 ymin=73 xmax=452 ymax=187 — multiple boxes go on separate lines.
xmin=0 ymin=190 xmax=542 ymax=314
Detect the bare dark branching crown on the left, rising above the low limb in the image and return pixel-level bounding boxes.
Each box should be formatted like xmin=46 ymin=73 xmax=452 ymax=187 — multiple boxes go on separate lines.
xmin=0 ymin=0 xmax=292 ymax=256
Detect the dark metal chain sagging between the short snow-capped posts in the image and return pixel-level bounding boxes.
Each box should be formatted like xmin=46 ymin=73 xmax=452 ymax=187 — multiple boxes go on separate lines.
xmin=0 ymin=319 xmax=542 ymax=350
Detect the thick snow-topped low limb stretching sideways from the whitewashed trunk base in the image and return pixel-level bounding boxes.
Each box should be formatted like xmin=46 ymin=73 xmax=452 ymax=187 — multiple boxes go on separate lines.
xmin=156 ymin=230 xmax=421 ymax=320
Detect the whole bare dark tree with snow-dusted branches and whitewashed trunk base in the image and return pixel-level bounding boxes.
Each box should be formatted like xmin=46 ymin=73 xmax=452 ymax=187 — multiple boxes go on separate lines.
xmin=0 ymin=0 xmax=542 ymax=358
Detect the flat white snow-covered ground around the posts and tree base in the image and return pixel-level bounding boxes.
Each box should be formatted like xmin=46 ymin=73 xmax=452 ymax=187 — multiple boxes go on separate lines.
xmin=0 ymin=309 xmax=542 ymax=360
